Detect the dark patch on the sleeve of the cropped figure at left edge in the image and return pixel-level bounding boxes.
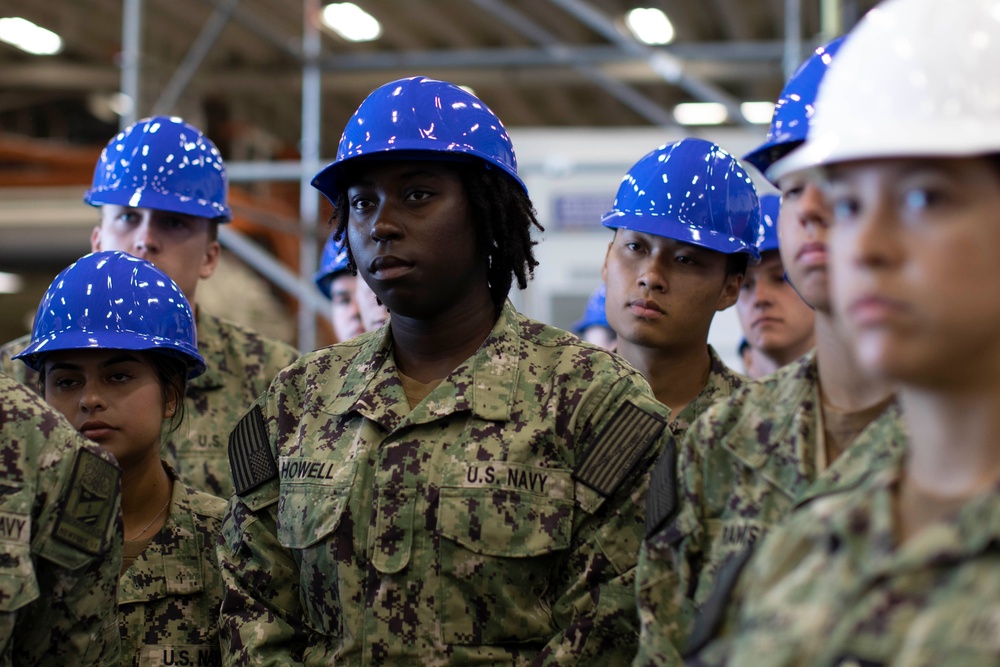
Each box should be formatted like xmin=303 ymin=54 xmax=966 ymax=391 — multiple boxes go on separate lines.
xmin=54 ymin=449 xmax=121 ymax=556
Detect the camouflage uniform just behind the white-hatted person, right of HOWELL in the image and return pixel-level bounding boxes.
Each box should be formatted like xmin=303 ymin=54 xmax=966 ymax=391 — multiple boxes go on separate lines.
xmin=634 ymin=352 xmax=899 ymax=666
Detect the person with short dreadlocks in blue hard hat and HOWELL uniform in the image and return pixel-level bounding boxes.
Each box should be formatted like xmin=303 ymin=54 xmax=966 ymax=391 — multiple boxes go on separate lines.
xmin=219 ymin=77 xmax=670 ymax=665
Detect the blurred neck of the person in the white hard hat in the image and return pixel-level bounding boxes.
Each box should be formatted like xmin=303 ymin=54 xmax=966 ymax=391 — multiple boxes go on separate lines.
xmin=899 ymin=383 xmax=1000 ymax=498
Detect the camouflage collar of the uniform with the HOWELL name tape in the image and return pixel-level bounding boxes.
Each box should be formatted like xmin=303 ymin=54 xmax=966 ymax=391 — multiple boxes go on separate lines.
xmin=328 ymin=301 xmax=524 ymax=430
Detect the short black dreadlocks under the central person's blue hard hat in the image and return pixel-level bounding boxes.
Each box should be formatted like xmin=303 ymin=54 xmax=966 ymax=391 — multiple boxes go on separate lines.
xmin=330 ymin=158 xmax=545 ymax=309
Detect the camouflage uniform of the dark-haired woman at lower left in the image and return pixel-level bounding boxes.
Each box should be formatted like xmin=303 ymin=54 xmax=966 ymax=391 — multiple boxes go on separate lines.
xmin=118 ymin=467 xmax=226 ymax=667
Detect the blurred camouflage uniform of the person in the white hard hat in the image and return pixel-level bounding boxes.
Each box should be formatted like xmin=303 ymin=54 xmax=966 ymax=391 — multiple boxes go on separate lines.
xmin=694 ymin=436 xmax=1000 ymax=667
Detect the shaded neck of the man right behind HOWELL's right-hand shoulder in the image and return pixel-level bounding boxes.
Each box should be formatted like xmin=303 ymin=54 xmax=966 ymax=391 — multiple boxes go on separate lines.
xmin=617 ymin=339 xmax=712 ymax=416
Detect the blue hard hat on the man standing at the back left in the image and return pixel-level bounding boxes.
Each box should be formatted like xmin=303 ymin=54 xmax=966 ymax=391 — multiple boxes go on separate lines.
xmin=83 ymin=116 xmax=232 ymax=222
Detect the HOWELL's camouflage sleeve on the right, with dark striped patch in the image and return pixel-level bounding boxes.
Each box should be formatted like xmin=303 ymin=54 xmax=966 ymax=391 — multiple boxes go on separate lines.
xmin=534 ymin=383 xmax=672 ymax=665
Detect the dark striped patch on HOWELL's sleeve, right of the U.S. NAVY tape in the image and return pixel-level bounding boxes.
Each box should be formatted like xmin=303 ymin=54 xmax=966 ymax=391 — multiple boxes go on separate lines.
xmin=573 ymin=403 xmax=667 ymax=496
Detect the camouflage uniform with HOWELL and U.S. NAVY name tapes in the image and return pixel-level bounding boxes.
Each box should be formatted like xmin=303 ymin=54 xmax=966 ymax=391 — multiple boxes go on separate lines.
xmin=219 ymin=302 xmax=670 ymax=666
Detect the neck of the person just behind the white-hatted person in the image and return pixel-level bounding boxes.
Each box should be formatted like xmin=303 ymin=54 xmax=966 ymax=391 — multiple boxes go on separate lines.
xmin=816 ymin=310 xmax=894 ymax=412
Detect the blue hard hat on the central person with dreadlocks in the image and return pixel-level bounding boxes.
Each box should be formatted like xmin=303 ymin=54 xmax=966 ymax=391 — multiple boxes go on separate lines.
xmin=312 ymin=76 xmax=527 ymax=204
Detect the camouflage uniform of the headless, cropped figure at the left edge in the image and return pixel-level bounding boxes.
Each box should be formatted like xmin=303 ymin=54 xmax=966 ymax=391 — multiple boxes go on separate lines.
xmin=0 ymin=374 xmax=122 ymax=667
